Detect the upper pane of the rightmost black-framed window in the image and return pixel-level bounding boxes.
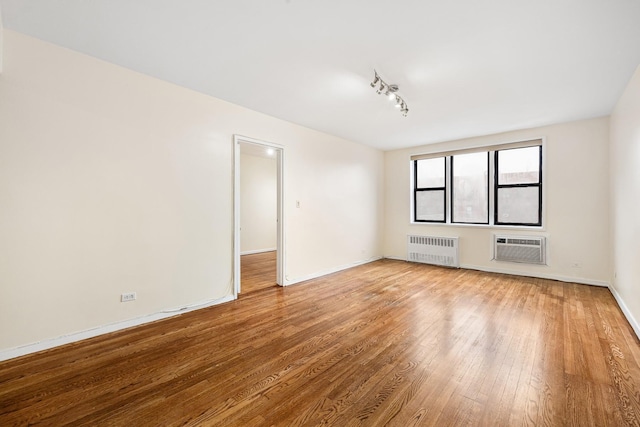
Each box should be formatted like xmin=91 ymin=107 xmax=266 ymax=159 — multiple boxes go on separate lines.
xmin=498 ymin=146 xmax=540 ymax=185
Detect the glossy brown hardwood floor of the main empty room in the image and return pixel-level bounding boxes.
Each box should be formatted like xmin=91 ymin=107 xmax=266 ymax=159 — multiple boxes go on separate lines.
xmin=0 ymin=260 xmax=640 ymax=427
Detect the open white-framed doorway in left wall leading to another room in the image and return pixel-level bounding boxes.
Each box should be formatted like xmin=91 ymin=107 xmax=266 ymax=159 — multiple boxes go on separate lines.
xmin=233 ymin=135 xmax=284 ymax=298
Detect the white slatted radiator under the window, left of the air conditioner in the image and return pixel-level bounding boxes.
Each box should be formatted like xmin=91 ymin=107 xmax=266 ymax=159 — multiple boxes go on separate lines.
xmin=407 ymin=235 xmax=460 ymax=268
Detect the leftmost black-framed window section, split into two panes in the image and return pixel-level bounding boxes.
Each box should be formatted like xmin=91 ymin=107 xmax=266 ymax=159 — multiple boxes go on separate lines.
xmin=413 ymin=157 xmax=446 ymax=222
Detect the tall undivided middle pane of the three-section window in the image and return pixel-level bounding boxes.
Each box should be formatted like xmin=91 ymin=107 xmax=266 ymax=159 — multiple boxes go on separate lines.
xmin=452 ymin=152 xmax=489 ymax=224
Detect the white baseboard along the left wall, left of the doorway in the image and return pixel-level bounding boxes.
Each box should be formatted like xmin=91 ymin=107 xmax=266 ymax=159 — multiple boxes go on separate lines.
xmin=0 ymin=295 xmax=234 ymax=362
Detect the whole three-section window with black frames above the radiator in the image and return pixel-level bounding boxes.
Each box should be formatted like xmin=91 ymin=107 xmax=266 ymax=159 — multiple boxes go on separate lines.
xmin=411 ymin=140 xmax=543 ymax=227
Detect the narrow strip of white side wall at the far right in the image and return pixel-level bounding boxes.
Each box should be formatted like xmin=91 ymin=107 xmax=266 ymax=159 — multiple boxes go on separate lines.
xmin=610 ymin=67 xmax=640 ymax=336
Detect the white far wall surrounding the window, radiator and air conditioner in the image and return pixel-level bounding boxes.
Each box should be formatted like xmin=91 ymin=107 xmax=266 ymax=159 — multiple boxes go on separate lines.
xmin=384 ymin=118 xmax=610 ymax=285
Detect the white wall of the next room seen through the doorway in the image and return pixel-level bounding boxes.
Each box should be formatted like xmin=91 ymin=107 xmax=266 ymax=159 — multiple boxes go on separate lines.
xmin=240 ymin=153 xmax=278 ymax=254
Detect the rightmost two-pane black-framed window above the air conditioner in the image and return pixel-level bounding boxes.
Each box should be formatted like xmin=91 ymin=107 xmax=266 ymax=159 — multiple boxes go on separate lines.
xmin=495 ymin=146 xmax=542 ymax=225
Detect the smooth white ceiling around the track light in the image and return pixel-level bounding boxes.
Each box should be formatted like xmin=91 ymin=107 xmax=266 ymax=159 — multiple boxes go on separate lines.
xmin=0 ymin=0 xmax=640 ymax=150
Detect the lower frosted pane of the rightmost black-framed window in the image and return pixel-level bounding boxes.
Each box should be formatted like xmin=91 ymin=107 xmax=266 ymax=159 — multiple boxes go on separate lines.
xmin=497 ymin=187 xmax=540 ymax=224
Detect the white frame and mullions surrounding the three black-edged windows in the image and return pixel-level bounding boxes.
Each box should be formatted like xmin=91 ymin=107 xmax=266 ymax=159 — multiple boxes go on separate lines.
xmin=408 ymin=137 xmax=546 ymax=227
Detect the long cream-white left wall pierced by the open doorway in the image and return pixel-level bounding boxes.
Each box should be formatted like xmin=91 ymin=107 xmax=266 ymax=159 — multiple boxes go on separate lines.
xmin=0 ymin=30 xmax=384 ymax=356
